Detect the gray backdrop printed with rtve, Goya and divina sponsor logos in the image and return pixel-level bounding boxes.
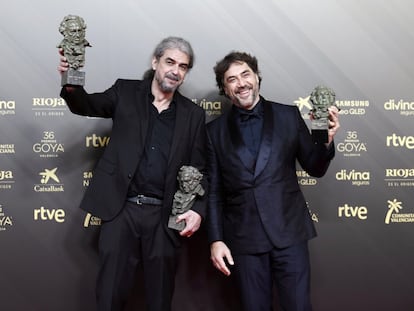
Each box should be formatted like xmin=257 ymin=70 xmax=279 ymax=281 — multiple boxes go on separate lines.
xmin=0 ymin=0 xmax=414 ymax=311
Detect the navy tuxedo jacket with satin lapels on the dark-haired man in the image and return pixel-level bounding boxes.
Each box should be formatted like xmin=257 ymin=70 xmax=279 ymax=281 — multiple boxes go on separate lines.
xmin=207 ymin=98 xmax=335 ymax=253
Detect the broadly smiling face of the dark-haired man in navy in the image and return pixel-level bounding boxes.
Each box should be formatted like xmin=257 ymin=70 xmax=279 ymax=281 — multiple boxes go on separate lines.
xmin=223 ymin=62 xmax=259 ymax=110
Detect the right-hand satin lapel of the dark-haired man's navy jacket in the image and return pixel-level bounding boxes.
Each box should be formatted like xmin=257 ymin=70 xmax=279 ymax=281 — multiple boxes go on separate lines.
xmin=254 ymin=98 xmax=275 ymax=177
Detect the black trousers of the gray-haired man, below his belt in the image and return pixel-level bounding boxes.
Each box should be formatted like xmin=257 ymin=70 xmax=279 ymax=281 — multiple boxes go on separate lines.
xmin=96 ymin=202 xmax=178 ymax=311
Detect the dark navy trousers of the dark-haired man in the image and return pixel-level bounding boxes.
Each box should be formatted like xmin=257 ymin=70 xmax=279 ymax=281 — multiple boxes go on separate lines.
xmin=231 ymin=242 xmax=312 ymax=311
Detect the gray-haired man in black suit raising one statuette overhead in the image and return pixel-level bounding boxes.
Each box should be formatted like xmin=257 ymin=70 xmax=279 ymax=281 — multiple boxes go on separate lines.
xmin=58 ymin=37 xmax=206 ymax=311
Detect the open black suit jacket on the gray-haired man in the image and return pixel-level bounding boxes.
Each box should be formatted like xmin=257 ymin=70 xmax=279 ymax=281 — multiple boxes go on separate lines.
xmin=61 ymin=79 xmax=207 ymax=246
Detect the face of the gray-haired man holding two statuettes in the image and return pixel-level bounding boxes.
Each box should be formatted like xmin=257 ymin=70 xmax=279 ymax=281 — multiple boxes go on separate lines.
xmin=152 ymin=49 xmax=189 ymax=93
